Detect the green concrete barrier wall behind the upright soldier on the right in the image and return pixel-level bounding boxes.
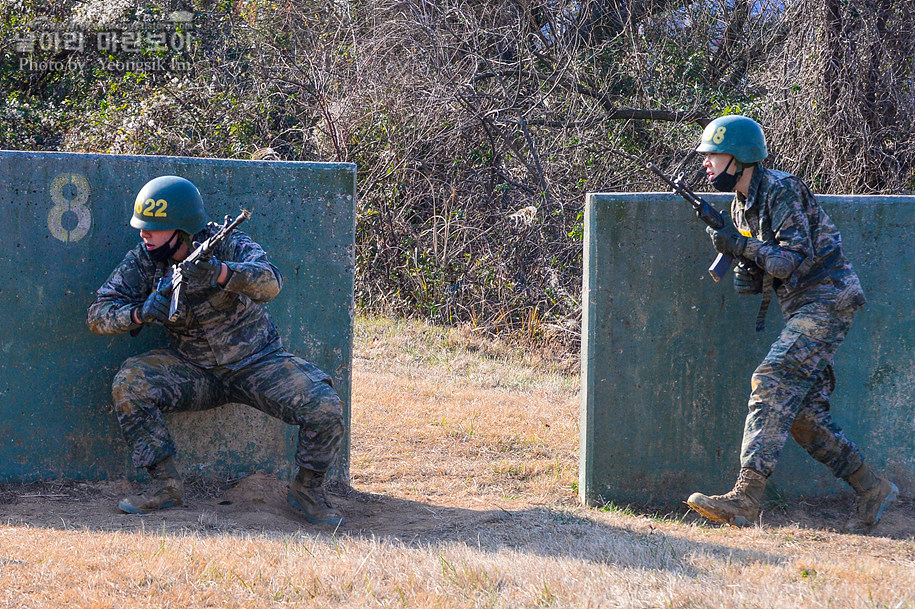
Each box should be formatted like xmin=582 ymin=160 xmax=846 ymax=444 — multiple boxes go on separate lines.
xmin=579 ymin=193 xmax=915 ymax=504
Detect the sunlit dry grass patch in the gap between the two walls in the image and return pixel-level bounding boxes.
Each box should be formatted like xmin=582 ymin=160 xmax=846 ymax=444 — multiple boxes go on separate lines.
xmin=352 ymin=320 xmax=579 ymax=505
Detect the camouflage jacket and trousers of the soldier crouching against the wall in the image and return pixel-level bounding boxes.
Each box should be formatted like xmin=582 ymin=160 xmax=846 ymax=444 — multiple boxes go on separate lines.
xmin=88 ymin=224 xmax=344 ymax=472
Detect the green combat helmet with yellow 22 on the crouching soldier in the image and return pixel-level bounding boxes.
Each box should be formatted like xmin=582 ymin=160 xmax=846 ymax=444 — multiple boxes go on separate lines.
xmin=130 ymin=176 xmax=206 ymax=235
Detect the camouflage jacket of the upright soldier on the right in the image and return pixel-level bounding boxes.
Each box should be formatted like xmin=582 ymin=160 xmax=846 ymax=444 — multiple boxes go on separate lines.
xmin=731 ymin=165 xmax=865 ymax=318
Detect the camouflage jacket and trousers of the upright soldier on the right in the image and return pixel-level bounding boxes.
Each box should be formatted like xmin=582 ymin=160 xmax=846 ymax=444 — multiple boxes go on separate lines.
xmin=731 ymin=165 xmax=865 ymax=478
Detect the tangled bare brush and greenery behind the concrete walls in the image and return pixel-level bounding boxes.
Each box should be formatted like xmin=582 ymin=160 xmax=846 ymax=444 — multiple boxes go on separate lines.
xmin=0 ymin=0 xmax=915 ymax=342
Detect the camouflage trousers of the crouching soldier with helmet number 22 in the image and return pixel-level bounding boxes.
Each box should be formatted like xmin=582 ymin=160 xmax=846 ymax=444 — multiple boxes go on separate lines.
xmin=111 ymin=349 xmax=344 ymax=472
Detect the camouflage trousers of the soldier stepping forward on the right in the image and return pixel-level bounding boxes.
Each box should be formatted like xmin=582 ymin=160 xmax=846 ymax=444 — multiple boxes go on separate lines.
xmin=740 ymin=303 xmax=863 ymax=478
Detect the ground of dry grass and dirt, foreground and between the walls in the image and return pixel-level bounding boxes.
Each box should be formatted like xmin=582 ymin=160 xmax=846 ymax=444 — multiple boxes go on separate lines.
xmin=0 ymin=319 xmax=915 ymax=609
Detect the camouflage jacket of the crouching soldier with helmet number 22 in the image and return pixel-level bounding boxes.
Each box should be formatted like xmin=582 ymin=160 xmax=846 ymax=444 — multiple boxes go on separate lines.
xmin=88 ymin=223 xmax=283 ymax=370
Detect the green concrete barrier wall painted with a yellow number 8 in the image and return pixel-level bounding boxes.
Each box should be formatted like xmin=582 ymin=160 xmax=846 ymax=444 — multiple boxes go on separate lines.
xmin=0 ymin=152 xmax=356 ymax=481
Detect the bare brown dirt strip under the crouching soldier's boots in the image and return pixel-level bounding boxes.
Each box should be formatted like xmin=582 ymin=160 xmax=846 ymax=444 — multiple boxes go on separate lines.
xmin=0 ymin=473 xmax=528 ymax=541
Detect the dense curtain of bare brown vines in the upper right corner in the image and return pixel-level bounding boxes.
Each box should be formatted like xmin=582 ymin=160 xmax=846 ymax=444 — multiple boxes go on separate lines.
xmin=762 ymin=0 xmax=915 ymax=193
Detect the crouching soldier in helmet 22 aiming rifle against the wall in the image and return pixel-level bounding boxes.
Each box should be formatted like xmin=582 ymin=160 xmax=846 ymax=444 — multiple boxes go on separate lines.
xmin=88 ymin=176 xmax=344 ymax=525
